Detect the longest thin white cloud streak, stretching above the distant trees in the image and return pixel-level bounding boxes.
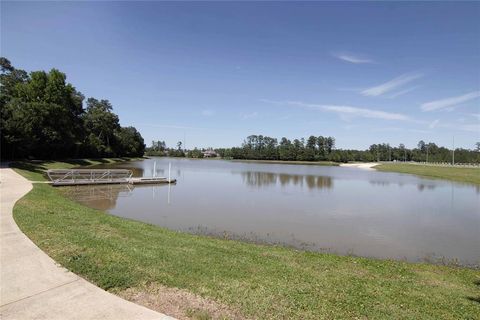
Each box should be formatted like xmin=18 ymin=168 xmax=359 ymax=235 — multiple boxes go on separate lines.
xmin=262 ymin=99 xmax=410 ymax=121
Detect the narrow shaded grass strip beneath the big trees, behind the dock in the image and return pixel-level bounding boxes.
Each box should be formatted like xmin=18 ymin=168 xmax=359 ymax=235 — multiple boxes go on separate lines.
xmin=10 ymin=158 xmax=141 ymax=181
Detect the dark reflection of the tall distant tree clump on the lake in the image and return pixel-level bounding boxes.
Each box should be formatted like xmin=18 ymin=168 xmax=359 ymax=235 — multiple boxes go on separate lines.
xmin=237 ymin=171 xmax=333 ymax=190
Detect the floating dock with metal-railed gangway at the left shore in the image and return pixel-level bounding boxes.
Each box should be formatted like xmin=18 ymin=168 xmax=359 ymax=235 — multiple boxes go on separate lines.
xmin=47 ymin=169 xmax=177 ymax=186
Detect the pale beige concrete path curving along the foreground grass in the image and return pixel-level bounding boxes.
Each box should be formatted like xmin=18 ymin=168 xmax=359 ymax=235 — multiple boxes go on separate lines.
xmin=0 ymin=168 xmax=173 ymax=320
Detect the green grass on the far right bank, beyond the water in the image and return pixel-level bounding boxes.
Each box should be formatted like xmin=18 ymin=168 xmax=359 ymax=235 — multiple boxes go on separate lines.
xmin=375 ymin=163 xmax=480 ymax=184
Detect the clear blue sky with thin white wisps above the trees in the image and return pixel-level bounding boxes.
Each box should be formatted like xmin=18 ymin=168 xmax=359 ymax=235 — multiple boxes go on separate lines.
xmin=1 ymin=1 xmax=480 ymax=149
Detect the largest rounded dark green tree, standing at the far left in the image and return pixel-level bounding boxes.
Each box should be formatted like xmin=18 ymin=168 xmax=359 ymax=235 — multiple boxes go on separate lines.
xmin=2 ymin=68 xmax=83 ymax=157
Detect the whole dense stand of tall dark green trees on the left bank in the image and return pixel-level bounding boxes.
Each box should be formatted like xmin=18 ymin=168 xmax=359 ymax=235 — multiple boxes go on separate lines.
xmin=0 ymin=57 xmax=145 ymax=159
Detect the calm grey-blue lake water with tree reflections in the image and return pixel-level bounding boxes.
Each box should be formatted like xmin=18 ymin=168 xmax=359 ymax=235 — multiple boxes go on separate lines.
xmin=64 ymin=158 xmax=480 ymax=265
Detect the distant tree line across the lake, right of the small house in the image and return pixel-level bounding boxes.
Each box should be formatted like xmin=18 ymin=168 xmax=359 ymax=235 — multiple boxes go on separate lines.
xmin=215 ymin=135 xmax=480 ymax=163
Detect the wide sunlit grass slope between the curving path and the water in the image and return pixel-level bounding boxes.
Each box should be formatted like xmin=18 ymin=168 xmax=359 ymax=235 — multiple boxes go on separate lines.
xmin=14 ymin=164 xmax=480 ymax=319
